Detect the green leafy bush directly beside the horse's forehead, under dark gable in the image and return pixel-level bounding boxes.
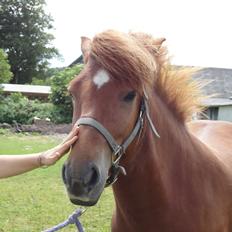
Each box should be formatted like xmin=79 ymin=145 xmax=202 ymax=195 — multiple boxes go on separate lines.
xmin=50 ymin=64 xmax=83 ymax=123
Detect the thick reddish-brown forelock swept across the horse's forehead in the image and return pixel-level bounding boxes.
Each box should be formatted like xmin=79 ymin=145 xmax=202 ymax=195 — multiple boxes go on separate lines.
xmin=90 ymin=30 xmax=157 ymax=90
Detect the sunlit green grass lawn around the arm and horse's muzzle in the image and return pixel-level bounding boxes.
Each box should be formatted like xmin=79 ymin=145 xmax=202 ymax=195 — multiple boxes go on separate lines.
xmin=0 ymin=133 xmax=114 ymax=232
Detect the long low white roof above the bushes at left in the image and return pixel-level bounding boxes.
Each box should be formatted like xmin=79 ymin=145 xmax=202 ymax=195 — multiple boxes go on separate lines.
xmin=0 ymin=84 xmax=51 ymax=96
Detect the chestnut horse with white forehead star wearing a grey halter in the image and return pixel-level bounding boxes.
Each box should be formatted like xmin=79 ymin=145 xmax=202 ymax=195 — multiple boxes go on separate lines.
xmin=63 ymin=30 xmax=232 ymax=232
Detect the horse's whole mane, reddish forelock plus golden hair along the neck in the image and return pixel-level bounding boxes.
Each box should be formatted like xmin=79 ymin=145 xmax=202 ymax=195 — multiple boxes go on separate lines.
xmin=90 ymin=30 xmax=205 ymax=122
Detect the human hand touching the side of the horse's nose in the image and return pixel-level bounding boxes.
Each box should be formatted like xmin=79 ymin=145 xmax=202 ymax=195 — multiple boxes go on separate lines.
xmin=38 ymin=125 xmax=79 ymax=166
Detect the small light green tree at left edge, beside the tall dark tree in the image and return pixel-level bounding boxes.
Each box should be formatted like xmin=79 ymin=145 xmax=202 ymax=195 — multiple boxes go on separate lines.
xmin=0 ymin=49 xmax=12 ymax=84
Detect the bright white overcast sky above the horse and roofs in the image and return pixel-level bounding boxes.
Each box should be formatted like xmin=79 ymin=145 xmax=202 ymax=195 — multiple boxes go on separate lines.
xmin=46 ymin=0 xmax=232 ymax=69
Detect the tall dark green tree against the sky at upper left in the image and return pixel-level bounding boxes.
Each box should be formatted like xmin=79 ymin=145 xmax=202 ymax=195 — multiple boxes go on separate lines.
xmin=0 ymin=0 xmax=58 ymax=83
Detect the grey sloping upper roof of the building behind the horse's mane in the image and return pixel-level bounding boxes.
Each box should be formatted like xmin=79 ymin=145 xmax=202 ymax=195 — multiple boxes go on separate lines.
xmin=194 ymin=68 xmax=232 ymax=99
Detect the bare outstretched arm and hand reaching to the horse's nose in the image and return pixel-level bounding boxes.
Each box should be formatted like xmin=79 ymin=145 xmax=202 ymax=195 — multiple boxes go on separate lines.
xmin=0 ymin=126 xmax=78 ymax=178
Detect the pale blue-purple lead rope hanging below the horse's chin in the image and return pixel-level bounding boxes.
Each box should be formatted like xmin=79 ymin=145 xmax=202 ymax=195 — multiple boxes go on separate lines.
xmin=43 ymin=209 xmax=85 ymax=232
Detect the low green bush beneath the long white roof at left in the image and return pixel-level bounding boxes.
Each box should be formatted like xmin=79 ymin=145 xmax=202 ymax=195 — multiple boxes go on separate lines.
xmin=0 ymin=93 xmax=54 ymax=124
